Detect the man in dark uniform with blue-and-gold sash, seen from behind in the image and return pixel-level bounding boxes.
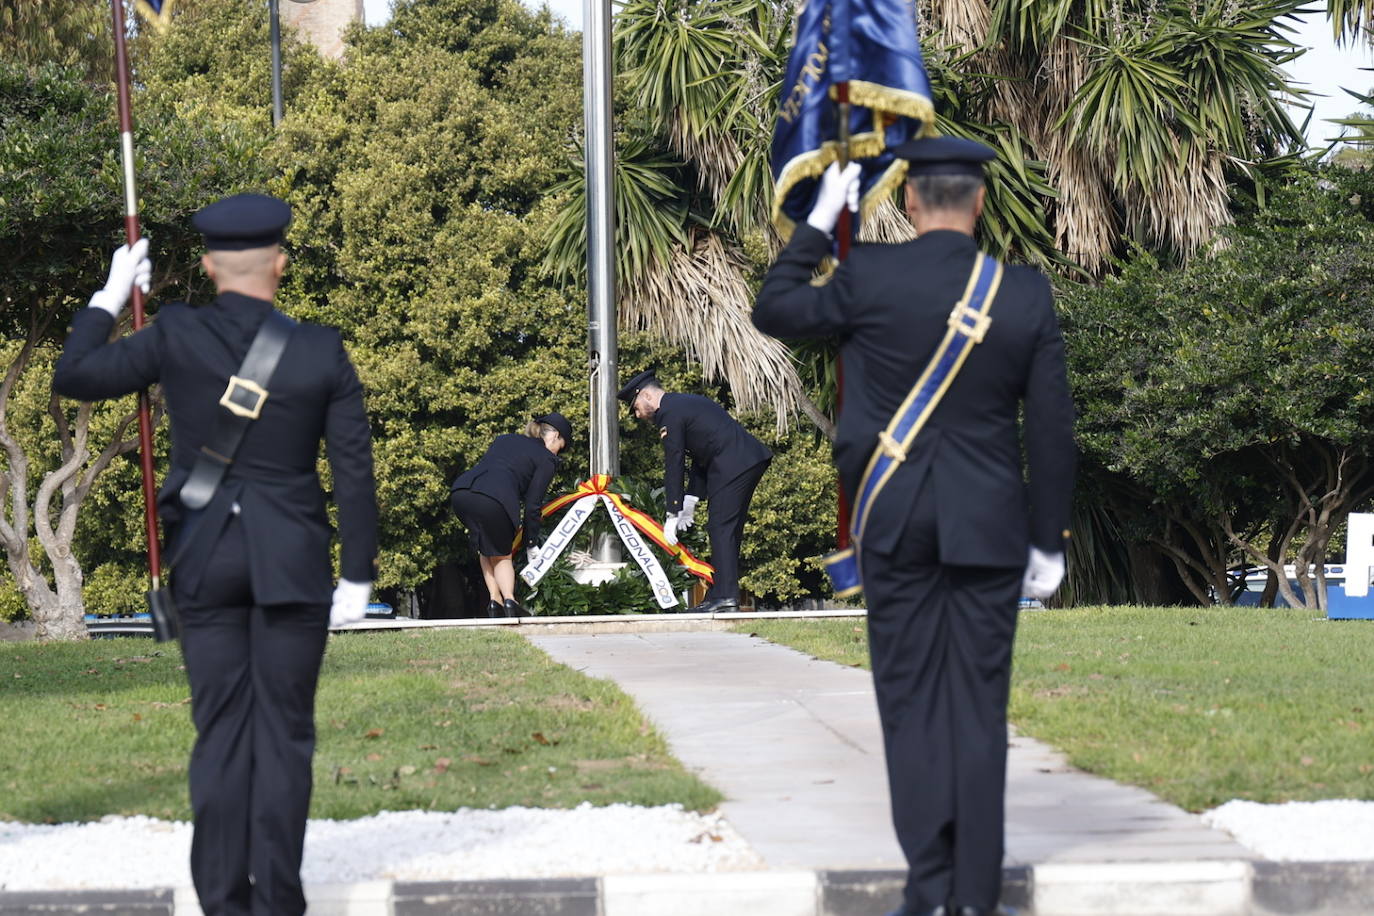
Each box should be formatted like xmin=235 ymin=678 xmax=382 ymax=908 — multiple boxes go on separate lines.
xmin=753 ymin=137 xmax=1076 ymax=916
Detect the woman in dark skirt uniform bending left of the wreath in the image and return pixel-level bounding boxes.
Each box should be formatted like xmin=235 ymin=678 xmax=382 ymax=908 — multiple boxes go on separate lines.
xmin=449 ymin=411 xmax=573 ymax=617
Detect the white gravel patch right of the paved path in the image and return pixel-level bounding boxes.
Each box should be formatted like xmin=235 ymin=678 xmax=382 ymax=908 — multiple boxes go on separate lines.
xmin=1202 ymin=799 xmax=1374 ymax=862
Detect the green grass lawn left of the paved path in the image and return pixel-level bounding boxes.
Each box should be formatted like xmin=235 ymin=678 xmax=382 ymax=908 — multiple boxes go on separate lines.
xmin=0 ymin=630 xmax=721 ymax=823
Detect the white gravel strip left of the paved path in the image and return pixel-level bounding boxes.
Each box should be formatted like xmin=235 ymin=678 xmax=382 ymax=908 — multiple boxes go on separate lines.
xmin=0 ymin=803 xmax=764 ymax=890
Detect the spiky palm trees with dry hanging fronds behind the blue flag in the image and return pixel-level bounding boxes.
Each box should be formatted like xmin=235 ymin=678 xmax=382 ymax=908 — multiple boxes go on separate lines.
xmin=548 ymin=0 xmax=1308 ymax=427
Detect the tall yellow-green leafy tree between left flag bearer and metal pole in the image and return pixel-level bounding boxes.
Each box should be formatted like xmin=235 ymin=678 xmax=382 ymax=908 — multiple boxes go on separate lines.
xmin=259 ymin=0 xmax=587 ymax=586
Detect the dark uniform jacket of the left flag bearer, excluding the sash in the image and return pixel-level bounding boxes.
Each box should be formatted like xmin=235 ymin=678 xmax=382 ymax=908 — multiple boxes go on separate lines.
xmin=52 ymin=293 xmax=376 ymax=604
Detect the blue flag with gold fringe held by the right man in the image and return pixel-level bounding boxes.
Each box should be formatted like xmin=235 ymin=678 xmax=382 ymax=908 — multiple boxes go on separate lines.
xmin=771 ymin=0 xmax=934 ymax=238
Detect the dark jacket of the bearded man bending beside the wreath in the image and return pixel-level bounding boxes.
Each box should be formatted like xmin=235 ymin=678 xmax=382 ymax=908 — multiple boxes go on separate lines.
xmin=654 ymin=391 xmax=772 ymax=512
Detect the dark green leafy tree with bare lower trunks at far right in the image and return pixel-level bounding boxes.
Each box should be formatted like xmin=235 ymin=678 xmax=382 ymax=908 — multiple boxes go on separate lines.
xmin=1063 ymin=168 xmax=1374 ymax=607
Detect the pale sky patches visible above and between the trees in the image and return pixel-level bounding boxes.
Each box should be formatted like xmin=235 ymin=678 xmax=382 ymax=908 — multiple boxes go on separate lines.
xmin=364 ymin=0 xmax=1374 ymax=144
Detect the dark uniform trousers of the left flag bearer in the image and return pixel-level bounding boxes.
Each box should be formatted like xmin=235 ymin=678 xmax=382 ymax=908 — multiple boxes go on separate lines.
xmin=173 ymin=516 xmax=330 ymax=916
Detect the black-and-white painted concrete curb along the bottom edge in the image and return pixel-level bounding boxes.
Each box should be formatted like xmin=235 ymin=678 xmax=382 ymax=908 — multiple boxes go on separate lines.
xmin=0 ymin=860 xmax=1374 ymax=916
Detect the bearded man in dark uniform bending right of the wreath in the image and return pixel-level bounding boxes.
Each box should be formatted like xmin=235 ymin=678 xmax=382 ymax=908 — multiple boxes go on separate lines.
xmin=616 ymin=369 xmax=772 ymax=614
